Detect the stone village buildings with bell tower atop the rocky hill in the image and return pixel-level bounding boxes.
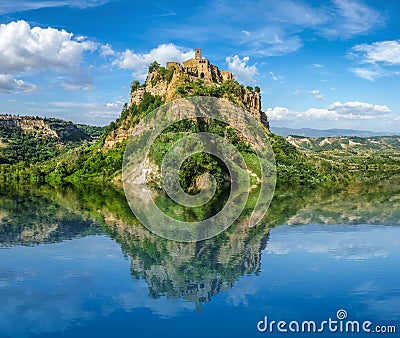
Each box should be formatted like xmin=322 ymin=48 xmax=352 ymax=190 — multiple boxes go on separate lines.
xmin=166 ymin=48 xmax=234 ymax=83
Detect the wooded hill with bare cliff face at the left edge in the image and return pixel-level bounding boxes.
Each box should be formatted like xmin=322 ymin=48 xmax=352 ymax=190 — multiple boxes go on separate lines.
xmin=0 ymin=115 xmax=102 ymax=164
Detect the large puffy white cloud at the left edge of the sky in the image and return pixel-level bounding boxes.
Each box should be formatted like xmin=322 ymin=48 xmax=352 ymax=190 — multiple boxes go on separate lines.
xmin=0 ymin=21 xmax=96 ymax=74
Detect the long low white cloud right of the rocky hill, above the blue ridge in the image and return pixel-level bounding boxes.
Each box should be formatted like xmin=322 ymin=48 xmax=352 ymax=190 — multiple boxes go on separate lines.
xmin=266 ymin=101 xmax=391 ymax=121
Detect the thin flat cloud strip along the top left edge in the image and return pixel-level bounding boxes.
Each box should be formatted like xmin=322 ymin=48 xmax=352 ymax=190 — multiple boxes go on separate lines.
xmin=0 ymin=0 xmax=109 ymax=14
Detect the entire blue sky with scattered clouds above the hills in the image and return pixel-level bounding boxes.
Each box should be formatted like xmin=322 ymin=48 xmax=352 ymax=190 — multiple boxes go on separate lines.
xmin=0 ymin=0 xmax=400 ymax=132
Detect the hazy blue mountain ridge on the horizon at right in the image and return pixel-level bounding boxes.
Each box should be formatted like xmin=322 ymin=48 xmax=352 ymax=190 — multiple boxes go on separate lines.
xmin=270 ymin=126 xmax=400 ymax=137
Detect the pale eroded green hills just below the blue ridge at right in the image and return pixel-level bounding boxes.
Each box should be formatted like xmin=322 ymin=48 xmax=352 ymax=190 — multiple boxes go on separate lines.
xmin=286 ymin=136 xmax=400 ymax=151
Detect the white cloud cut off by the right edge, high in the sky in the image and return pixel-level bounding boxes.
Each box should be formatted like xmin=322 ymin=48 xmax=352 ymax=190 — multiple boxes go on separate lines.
xmin=352 ymin=40 xmax=400 ymax=65
